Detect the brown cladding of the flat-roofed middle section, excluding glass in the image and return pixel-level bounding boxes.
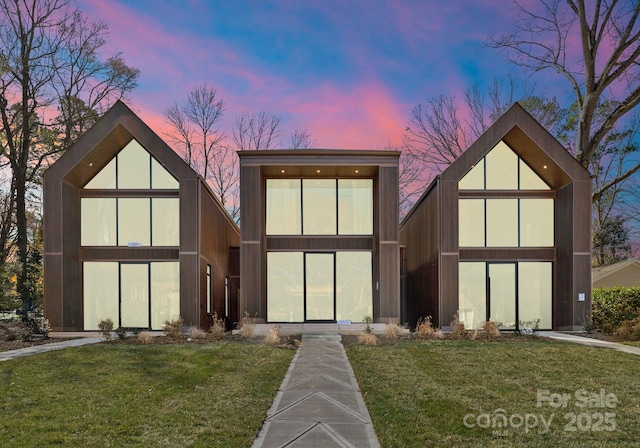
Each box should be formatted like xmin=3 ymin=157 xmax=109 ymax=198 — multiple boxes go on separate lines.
xmin=239 ymin=150 xmax=400 ymax=322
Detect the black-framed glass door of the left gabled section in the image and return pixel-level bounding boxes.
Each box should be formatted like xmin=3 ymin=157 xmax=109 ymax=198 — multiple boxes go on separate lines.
xmin=120 ymin=263 xmax=149 ymax=328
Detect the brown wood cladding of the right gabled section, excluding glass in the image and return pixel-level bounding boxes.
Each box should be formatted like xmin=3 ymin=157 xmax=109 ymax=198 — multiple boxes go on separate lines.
xmin=400 ymin=105 xmax=591 ymax=330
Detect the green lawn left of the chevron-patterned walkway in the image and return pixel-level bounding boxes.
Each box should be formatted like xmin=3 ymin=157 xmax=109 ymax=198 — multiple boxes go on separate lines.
xmin=0 ymin=343 xmax=294 ymax=447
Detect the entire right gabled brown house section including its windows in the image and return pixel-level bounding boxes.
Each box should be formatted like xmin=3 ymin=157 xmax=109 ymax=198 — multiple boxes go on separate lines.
xmin=400 ymin=104 xmax=591 ymax=330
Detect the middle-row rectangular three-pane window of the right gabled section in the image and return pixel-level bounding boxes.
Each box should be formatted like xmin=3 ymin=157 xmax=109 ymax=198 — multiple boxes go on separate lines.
xmin=458 ymin=198 xmax=554 ymax=247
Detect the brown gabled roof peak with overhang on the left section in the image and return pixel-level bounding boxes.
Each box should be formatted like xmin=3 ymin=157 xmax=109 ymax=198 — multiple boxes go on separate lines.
xmin=44 ymin=101 xmax=198 ymax=188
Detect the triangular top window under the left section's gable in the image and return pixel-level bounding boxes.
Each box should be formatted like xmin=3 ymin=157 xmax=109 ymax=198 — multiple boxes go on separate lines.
xmin=84 ymin=140 xmax=179 ymax=190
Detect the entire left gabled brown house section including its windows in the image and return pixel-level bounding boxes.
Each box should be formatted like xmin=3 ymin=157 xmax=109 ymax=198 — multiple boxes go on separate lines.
xmin=44 ymin=102 xmax=240 ymax=331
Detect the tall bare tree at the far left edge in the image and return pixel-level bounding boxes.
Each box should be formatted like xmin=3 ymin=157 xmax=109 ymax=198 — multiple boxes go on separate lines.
xmin=0 ymin=0 xmax=137 ymax=315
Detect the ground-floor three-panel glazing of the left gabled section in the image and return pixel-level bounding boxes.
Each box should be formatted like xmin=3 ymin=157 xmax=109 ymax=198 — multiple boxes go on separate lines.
xmin=83 ymin=261 xmax=180 ymax=330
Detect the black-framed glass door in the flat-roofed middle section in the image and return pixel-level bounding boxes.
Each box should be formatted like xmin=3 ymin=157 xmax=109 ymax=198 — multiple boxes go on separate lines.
xmin=304 ymin=253 xmax=336 ymax=321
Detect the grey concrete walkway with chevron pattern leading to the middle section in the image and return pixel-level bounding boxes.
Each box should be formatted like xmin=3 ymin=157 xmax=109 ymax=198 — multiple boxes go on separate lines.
xmin=253 ymin=334 xmax=380 ymax=448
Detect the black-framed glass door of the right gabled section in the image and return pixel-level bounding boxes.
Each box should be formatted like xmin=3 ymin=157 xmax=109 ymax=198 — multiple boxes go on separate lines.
xmin=487 ymin=263 xmax=518 ymax=330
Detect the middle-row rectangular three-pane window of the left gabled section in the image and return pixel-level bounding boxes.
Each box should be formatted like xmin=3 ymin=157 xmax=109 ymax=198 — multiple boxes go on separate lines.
xmin=80 ymin=198 xmax=180 ymax=246
